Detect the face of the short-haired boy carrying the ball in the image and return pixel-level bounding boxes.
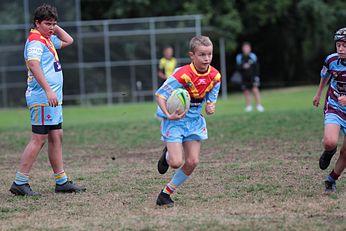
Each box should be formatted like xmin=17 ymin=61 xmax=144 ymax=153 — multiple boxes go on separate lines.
xmin=189 ymin=45 xmax=213 ymax=72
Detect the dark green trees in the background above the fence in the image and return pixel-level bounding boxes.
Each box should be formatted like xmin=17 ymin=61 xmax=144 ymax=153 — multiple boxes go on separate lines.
xmin=81 ymin=0 xmax=346 ymax=86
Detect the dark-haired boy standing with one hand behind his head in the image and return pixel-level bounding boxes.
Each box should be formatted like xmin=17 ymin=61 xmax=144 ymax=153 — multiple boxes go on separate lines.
xmin=10 ymin=4 xmax=85 ymax=196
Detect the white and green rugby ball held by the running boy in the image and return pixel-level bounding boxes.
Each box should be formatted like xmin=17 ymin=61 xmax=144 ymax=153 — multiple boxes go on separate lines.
xmin=167 ymin=88 xmax=190 ymax=114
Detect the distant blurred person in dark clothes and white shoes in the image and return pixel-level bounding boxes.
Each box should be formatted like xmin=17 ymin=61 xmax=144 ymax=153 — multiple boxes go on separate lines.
xmin=236 ymin=42 xmax=264 ymax=112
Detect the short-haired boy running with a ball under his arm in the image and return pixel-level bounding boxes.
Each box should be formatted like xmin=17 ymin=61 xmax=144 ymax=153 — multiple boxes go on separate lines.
xmin=156 ymin=36 xmax=221 ymax=207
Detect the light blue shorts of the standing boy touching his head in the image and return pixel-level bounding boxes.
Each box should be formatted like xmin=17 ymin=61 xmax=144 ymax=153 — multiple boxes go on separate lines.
xmin=30 ymin=105 xmax=63 ymax=125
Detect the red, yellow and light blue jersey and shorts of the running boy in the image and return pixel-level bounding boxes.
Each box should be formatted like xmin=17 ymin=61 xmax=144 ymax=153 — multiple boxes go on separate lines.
xmin=156 ymin=64 xmax=221 ymax=143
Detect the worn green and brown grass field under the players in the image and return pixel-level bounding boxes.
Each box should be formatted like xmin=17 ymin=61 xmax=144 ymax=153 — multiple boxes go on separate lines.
xmin=0 ymin=87 xmax=346 ymax=230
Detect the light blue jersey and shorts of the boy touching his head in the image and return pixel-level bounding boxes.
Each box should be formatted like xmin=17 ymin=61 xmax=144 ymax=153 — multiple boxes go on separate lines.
xmin=24 ymin=29 xmax=63 ymax=125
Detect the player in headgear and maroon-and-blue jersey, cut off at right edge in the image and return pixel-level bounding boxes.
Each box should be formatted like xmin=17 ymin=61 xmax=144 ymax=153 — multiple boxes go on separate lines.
xmin=313 ymin=27 xmax=346 ymax=193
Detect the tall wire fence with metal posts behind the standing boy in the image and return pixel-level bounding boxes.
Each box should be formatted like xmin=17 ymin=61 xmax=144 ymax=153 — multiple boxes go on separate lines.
xmin=0 ymin=0 xmax=227 ymax=108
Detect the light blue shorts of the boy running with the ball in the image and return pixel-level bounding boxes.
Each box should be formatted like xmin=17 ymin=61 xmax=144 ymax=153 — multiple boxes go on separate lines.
xmin=161 ymin=115 xmax=208 ymax=143
